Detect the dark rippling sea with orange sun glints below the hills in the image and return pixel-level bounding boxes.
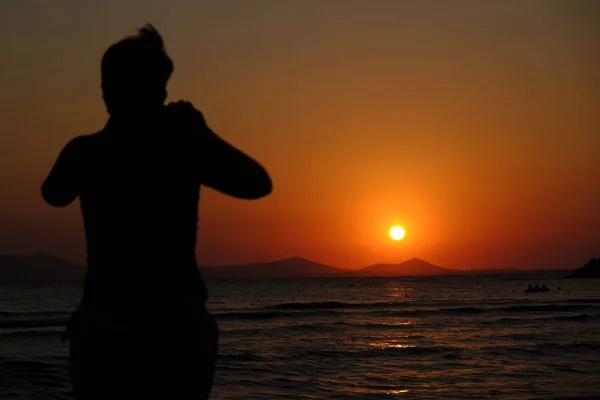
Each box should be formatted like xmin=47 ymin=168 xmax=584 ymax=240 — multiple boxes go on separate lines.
xmin=0 ymin=276 xmax=600 ymax=400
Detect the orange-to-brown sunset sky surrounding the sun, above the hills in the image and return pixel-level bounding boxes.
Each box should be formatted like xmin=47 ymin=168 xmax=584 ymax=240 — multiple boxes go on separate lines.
xmin=0 ymin=0 xmax=600 ymax=268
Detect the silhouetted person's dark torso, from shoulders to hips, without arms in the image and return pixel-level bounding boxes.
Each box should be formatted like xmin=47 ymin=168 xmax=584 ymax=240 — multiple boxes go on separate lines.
xmin=80 ymin=112 xmax=206 ymax=306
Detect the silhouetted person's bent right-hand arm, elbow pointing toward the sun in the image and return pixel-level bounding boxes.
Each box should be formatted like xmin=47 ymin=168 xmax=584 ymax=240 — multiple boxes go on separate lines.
xmin=170 ymin=102 xmax=273 ymax=200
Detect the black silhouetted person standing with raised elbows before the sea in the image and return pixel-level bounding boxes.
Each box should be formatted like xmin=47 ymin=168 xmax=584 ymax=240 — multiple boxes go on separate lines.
xmin=42 ymin=25 xmax=272 ymax=400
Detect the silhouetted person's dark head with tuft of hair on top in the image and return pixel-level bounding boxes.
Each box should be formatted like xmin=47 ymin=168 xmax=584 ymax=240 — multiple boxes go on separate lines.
xmin=102 ymin=24 xmax=173 ymax=115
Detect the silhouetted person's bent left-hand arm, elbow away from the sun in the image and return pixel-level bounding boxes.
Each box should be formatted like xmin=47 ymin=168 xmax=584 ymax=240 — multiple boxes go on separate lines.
xmin=42 ymin=138 xmax=81 ymax=207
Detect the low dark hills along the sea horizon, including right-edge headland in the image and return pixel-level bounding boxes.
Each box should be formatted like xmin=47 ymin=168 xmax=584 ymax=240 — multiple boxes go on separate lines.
xmin=0 ymin=254 xmax=600 ymax=283
